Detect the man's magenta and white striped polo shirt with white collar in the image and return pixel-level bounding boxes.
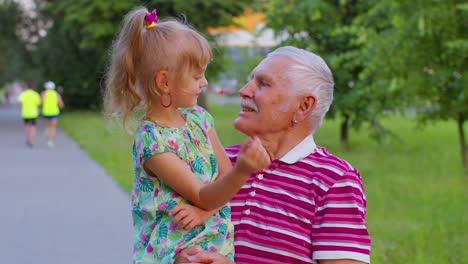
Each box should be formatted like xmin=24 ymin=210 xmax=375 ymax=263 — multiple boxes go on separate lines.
xmin=225 ymin=136 xmax=370 ymax=264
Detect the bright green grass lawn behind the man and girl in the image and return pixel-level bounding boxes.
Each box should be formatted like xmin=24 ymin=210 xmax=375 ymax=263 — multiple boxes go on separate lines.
xmin=61 ymin=104 xmax=468 ymax=264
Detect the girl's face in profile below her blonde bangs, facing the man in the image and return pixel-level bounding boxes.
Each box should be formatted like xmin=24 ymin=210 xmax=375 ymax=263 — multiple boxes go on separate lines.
xmin=172 ymin=65 xmax=208 ymax=108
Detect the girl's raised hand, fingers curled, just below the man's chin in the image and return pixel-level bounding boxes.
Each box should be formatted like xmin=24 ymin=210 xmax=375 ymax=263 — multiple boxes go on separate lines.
xmin=235 ymin=137 xmax=271 ymax=174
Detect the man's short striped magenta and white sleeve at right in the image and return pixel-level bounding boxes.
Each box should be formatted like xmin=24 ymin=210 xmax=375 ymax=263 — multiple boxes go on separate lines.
xmin=312 ymin=171 xmax=371 ymax=263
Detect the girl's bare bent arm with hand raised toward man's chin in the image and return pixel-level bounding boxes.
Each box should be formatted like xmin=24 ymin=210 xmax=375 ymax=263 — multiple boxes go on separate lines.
xmin=144 ymin=137 xmax=270 ymax=211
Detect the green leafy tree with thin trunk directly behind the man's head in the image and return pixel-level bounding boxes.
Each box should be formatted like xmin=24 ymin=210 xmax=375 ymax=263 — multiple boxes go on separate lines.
xmin=263 ymin=0 xmax=389 ymax=148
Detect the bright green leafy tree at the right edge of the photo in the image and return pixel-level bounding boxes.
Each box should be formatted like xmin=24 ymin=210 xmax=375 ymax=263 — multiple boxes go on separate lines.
xmin=374 ymin=0 xmax=468 ymax=172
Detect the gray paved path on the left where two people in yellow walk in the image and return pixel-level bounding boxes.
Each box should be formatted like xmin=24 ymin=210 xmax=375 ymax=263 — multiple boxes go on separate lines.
xmin=0 ymin=105 xmax=132 ymax=264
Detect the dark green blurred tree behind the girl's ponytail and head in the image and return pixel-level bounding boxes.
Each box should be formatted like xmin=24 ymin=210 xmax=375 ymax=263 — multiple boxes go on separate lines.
xmin=30 ymin=0 xmax=251 ymax=108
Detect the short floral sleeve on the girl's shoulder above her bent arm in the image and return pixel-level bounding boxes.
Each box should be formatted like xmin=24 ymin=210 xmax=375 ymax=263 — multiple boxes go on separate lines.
xmin=134 ymin=123 xmax=171 ymax=164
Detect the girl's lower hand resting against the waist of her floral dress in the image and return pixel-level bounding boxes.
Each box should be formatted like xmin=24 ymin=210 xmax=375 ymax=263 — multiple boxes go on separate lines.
xmin=168 ymin=204 xmax=212 ymax=231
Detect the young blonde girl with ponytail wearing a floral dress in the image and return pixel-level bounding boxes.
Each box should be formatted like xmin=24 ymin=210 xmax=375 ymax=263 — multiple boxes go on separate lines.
xmin=104 ymin=8 xmax=270 ymax=263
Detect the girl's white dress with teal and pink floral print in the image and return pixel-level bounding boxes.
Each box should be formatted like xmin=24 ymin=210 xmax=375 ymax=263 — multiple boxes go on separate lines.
xmin=132 ymin=106 xmax=234 ymax=264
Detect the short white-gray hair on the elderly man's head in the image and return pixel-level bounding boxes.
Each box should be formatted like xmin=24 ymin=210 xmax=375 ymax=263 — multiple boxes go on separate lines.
xmin=267 ymin=46 xmax=334 ymax=132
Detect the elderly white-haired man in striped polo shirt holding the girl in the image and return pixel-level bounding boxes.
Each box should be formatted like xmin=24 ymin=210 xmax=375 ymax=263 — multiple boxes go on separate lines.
xmin=181 ymin=47 xmax=370 ymax=264
